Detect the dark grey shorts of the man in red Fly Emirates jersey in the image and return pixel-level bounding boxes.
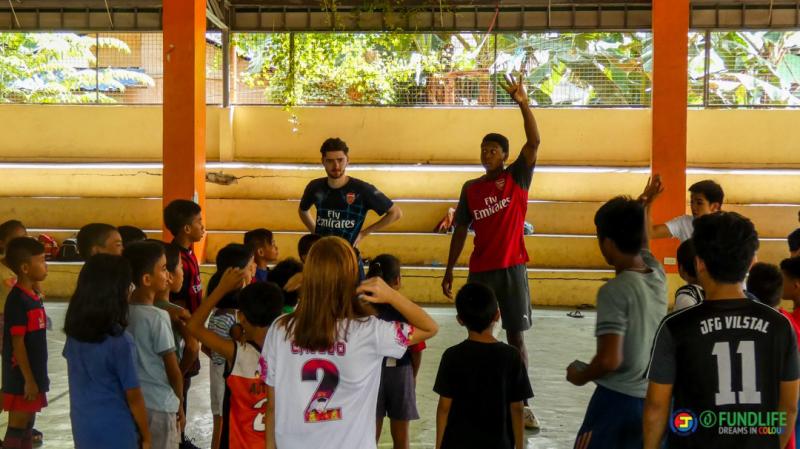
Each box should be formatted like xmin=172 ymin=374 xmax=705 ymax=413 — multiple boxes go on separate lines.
xmin=467 ymin=264 xmax=533 ymax=332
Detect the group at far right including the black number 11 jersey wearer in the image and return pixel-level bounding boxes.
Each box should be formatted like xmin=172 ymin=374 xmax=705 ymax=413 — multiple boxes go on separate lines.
xmin=567 ymin=177 xmax=800 ymax=449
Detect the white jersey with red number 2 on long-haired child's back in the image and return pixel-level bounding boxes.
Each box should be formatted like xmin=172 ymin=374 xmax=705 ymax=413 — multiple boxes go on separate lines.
xmin=262 ymin=316 xmax=414 ymax=449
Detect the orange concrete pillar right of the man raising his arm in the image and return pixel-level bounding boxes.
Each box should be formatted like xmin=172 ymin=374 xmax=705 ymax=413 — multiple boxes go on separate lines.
xmin=651 ymin=0 xmax=689 ymax=272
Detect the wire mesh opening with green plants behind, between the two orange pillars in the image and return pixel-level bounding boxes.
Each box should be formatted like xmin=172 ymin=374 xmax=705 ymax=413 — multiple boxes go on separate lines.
xmin=234 ymin=32 xmax=652 ymax=107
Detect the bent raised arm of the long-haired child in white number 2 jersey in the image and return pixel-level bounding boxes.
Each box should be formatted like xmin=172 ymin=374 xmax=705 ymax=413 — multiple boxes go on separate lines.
xmin=356 ymin=276 xmax=439 ymax=346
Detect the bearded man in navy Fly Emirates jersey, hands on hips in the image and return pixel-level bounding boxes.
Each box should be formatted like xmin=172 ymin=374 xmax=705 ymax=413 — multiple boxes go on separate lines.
xmin=298 ymin=137 xmax=403 ymax=246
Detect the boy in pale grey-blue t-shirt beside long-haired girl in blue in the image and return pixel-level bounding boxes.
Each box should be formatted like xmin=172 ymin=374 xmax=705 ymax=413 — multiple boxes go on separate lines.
xmin=123 ymin=241 xmax=186 ymax=449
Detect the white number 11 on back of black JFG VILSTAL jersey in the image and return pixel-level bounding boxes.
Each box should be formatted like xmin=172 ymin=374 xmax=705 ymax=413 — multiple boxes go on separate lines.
xmin=711 ymin=340 xmax=761 ymax=405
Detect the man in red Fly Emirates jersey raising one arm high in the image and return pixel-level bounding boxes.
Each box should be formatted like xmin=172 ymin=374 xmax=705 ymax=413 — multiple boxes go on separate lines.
xmin=442 ymin=75 xmax=539 ymax=428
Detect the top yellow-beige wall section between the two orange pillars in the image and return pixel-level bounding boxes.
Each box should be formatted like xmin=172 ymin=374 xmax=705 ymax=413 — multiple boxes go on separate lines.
xmin=234 ymin=107 xmax=650 ymax=165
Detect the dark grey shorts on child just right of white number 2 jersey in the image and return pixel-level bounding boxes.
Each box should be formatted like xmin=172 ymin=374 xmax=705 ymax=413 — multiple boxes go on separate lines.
xmin=378 ymin=359 xmax=419 ymax=421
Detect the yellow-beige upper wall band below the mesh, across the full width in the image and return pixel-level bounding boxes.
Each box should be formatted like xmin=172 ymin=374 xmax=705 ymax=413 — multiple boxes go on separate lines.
xmin=0 ymin=105 xmax=800 ymax=167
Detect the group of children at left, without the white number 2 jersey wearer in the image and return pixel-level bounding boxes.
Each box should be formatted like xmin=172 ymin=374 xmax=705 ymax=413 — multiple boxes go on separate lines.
xmin=0 ymin=200 xmax=444 ymax=449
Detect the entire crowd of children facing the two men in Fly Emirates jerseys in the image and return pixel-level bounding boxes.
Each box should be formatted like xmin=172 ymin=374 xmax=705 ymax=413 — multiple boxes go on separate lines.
xmin=0 ymin=172 xmax=800 ymax=449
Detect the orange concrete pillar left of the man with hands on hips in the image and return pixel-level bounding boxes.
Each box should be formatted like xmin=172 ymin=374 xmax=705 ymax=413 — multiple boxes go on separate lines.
xmin=162 ymin=0 xmax=206 ymax=261
